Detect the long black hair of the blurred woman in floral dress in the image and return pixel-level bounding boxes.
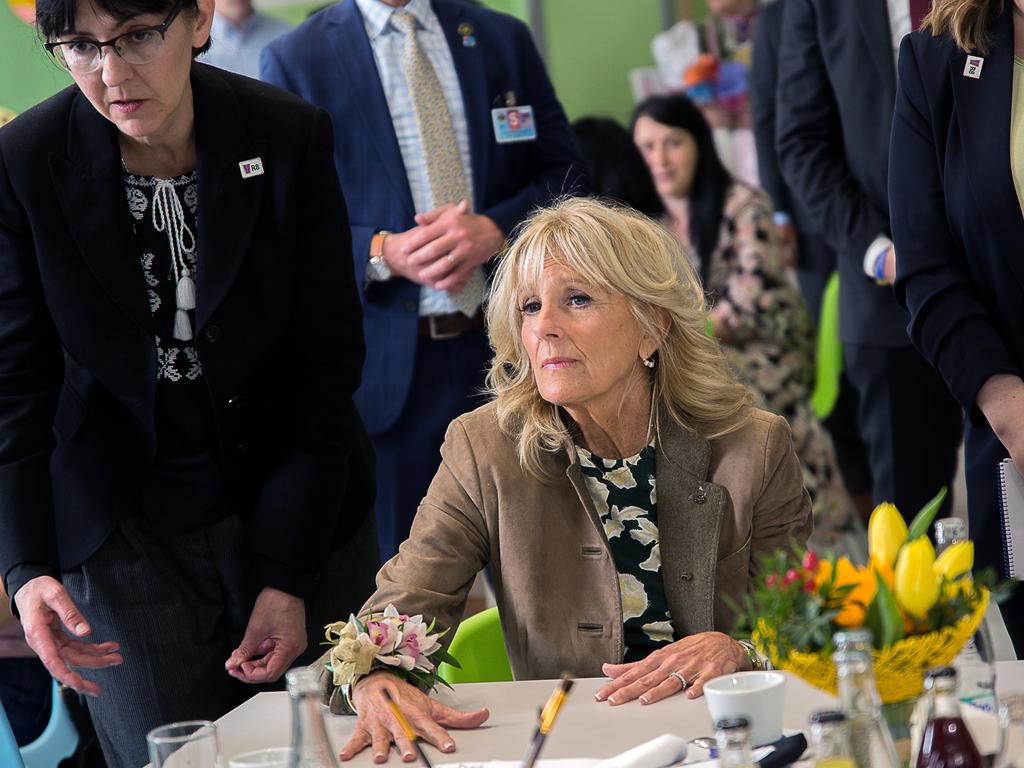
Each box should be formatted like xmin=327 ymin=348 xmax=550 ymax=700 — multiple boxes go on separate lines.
xmin=630 ymin=95 xmax=733 ymax=282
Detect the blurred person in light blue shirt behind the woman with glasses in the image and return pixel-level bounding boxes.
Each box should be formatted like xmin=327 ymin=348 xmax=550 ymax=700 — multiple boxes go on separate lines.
xmin=200 ymin=0 xmax=292 ymax=78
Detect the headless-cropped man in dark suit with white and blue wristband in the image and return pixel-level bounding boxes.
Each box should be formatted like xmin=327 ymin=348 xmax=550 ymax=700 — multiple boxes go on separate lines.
xmin=775 ymin=0 xmax=962 ymax=520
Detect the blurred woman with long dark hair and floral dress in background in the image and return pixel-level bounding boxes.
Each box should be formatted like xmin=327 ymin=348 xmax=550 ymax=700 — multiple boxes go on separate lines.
xmin=632 ymin=95 xmax=852 ymax=543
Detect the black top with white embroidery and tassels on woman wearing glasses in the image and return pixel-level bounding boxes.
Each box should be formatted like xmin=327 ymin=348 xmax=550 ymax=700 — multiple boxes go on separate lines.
xmin=124 ymin=171 xmax=225 ymax=528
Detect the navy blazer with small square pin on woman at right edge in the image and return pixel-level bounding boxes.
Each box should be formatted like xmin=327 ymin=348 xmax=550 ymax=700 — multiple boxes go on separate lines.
xmin=889 ymin=3 xmax=1024 ymax=424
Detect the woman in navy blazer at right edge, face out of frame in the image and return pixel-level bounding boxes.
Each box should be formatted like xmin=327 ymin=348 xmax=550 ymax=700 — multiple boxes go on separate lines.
xmin=889 ymin=0 xmax=1024 ymax=654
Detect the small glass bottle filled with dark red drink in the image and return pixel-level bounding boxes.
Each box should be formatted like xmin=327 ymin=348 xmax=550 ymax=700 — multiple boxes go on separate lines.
xmin=915 ymin=667 xmax=985 ymax=768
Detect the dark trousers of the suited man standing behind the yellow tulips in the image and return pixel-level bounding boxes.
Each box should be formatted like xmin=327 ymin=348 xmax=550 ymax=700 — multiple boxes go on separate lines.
xmin=843 ymin=344 xmax=963 ymax=521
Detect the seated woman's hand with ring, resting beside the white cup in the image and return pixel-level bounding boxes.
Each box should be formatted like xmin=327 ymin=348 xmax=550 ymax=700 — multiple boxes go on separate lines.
xmin=594 ymin=632 xmax=751 ymax=705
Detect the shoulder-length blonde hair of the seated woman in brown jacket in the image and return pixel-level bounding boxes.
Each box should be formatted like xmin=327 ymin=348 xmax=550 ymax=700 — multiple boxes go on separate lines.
xmin=487 ymin=198 xmax=751 ymax=476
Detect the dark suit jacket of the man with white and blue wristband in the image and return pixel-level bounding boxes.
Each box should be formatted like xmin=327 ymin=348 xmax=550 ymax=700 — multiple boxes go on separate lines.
xmin=776 ymin=0 xmax=910 ymax=347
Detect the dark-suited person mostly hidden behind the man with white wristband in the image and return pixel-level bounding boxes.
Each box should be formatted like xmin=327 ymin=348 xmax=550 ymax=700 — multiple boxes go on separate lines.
xmin=751 ymin=0 xmax=874 ymax=520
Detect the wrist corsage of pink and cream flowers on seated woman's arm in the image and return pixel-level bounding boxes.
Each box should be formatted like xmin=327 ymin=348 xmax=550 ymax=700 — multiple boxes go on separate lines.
xmin=325 ymin=605 xmax=459 ymax=690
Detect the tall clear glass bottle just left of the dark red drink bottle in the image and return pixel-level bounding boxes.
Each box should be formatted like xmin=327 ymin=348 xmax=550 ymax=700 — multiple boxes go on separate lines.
xmin=833 ymin=648 xmax=902 ymax=768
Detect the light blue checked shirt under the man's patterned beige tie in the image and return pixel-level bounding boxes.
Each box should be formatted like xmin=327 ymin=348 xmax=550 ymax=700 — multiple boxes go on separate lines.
xmin=355 ymin=0 xmax=473 ymax=315
